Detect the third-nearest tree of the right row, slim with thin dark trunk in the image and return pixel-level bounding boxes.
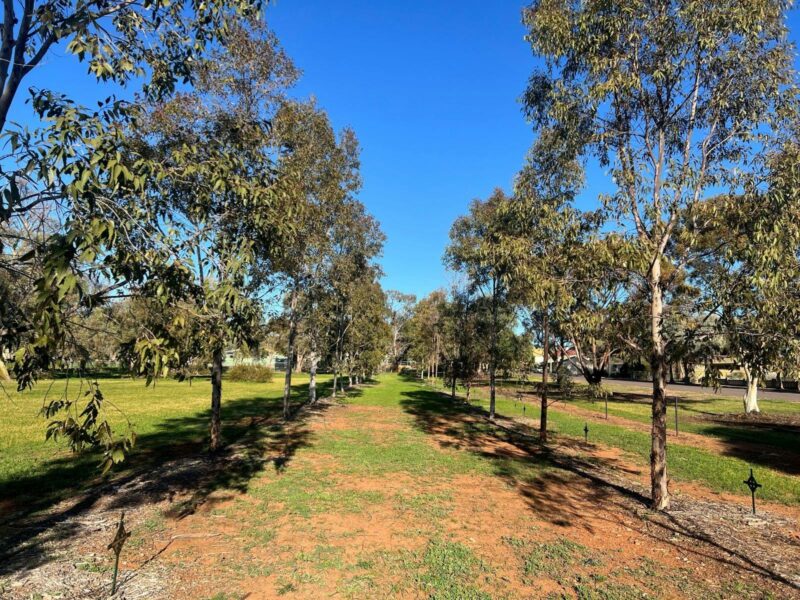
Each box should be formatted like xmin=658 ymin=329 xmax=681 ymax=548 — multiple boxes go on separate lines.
xmin=444 ymin=189 xmax=518 ymax=419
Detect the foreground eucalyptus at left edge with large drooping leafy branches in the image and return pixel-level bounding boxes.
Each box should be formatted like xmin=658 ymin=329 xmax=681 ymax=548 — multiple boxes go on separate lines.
xmin=0 ymin=0 xmax=260 ymax=466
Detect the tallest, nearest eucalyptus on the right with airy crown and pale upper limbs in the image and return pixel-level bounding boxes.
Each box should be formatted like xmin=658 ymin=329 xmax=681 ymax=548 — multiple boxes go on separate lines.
xmin=523 ymin=0 xmax=795 ymax=509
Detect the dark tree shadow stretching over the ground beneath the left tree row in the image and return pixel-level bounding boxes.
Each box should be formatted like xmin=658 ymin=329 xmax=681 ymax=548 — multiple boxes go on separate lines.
xmin=0 ymin=382 xmax=331 ymax=575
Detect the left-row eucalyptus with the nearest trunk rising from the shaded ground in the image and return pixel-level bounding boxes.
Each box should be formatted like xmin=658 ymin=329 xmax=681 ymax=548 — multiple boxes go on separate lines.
xmin=133 ymin=21 xmax=303 ymax=451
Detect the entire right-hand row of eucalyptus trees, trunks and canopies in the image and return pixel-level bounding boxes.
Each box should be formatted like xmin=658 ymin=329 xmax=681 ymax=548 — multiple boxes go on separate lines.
xmin=408 ymin=0 xmax=800 ymax=509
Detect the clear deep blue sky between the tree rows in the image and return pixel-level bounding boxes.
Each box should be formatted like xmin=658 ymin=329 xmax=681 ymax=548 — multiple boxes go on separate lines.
xmin=11 ymin=0 xmax=800 ymax=296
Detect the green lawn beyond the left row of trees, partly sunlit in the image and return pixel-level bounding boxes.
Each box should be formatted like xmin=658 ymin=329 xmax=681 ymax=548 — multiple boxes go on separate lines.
xmin=0 ymin=374 xmax=330 ymax=504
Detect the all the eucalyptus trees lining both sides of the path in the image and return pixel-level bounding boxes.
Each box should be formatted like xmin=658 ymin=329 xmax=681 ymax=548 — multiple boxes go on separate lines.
xmin=0 ymin=0 xmax=800 ymax=509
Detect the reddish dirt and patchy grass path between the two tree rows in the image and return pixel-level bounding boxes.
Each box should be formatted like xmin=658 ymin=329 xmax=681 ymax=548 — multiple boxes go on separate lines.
xmin=0 ymin=383 xmax=800 ymax=599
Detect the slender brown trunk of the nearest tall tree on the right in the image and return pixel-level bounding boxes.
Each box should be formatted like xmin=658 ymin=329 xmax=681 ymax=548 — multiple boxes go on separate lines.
xmin=650 ymin=264 xmax=669 ymax=510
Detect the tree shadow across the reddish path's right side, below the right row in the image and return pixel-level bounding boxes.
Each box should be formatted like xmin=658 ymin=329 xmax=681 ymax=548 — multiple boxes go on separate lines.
xmin=401 ymin=390 xmax=800 ymax=590
